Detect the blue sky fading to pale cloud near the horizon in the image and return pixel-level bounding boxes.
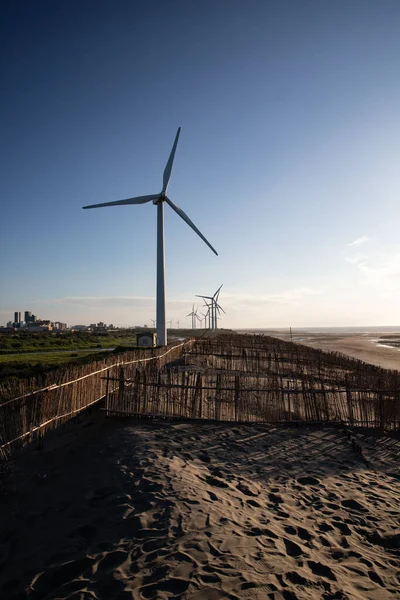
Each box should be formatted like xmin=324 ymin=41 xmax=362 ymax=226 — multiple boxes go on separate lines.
xmin=0 ymin=0 xmax=400 ymax=327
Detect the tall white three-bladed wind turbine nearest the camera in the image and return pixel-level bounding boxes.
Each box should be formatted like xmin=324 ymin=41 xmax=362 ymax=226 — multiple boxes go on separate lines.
xmin=83 ymin=127 xmax=218 ymax=346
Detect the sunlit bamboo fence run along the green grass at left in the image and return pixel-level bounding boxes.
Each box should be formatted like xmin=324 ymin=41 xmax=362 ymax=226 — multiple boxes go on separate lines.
xmin=0 ymin=341 xmax=192 ymax=460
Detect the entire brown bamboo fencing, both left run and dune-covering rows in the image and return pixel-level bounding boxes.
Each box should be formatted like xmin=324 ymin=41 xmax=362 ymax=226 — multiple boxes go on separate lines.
xmin=0 ymin=334 xmax=400 ymax=460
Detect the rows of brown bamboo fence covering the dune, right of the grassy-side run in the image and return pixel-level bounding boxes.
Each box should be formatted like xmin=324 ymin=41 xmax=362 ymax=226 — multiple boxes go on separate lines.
xmin=105 ymin=335 xmax=400 ymax=430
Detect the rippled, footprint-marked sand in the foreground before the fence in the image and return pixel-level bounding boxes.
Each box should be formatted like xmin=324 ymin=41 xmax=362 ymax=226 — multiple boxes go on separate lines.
xmin=0 ymin=413 xmax=400 ymax=600
